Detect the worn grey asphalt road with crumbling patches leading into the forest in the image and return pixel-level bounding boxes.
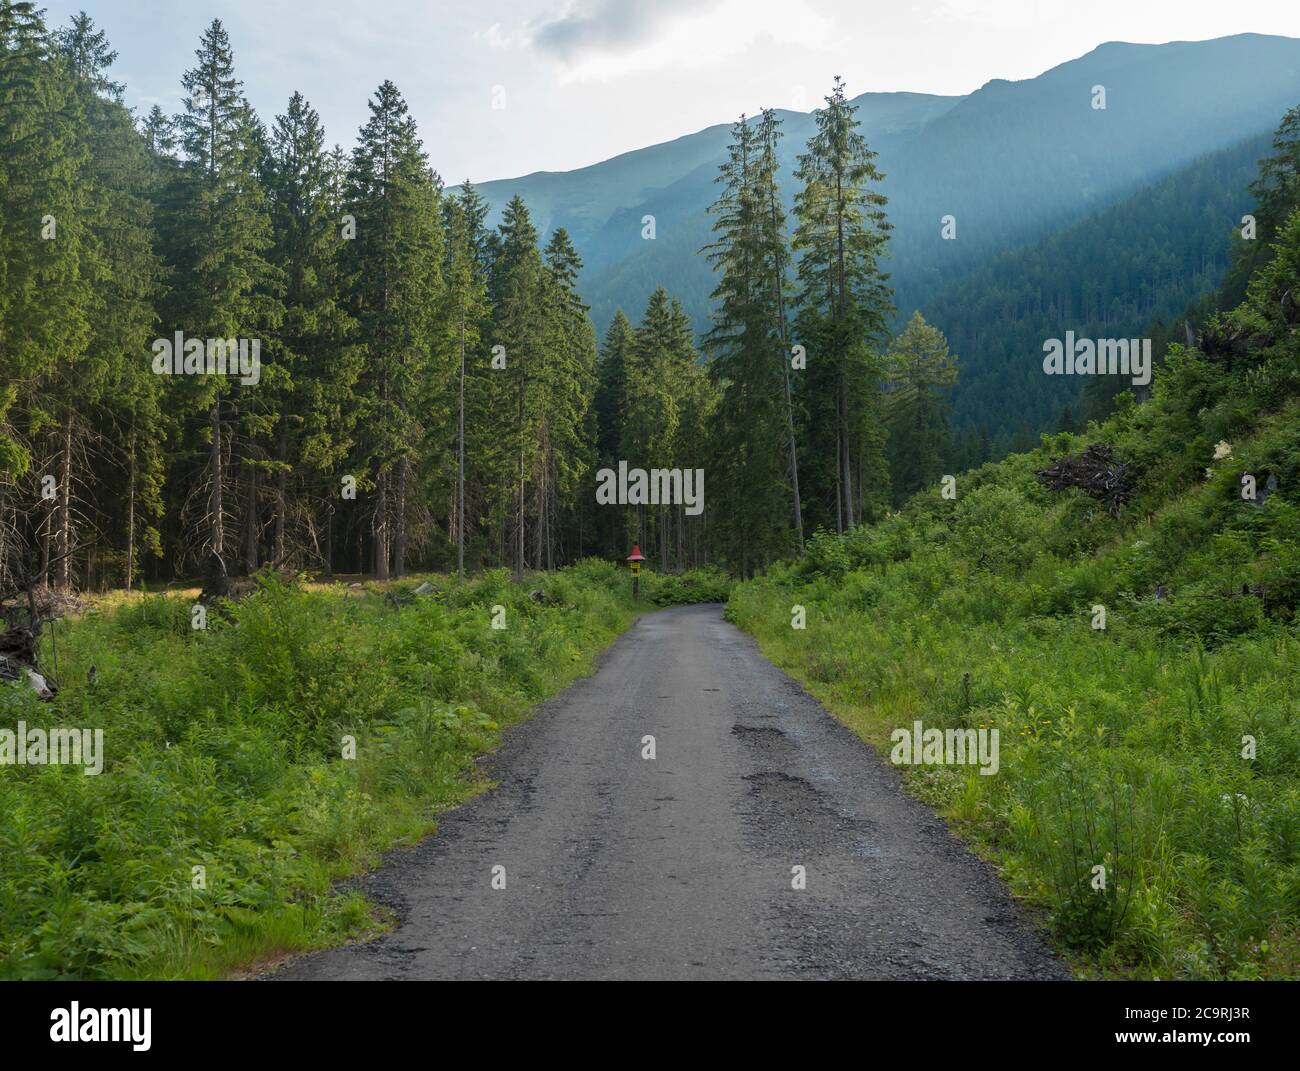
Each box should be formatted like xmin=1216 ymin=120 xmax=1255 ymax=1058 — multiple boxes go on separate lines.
xmin=270 ymin=606 xmax=1069 ymax=979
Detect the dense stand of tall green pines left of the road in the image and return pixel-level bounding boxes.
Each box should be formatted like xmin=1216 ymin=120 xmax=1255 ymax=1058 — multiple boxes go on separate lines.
xmin=0 ymin=12 xmax=647 ymax=590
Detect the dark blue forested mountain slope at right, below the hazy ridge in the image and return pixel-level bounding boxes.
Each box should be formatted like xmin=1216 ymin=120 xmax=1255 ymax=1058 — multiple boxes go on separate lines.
xmin=922 ymin=135 xmax=1269 ymax=450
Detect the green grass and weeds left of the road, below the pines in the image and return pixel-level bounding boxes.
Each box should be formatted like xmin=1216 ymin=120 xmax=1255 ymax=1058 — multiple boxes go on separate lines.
xmin=0 ymin=560 xmax=712 ymax=979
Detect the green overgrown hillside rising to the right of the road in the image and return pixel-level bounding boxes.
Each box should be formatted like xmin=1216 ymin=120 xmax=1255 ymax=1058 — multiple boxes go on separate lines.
xmin=729 ymin=212 xmax=1300 ymax=979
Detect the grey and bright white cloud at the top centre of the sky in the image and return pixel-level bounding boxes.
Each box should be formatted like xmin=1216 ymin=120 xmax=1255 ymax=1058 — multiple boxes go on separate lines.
xmin=506 ymin=0 xmax=833 ymax=82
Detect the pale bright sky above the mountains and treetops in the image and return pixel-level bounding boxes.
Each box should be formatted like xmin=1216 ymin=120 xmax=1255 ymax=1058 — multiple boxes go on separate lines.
xmin=42 ymin=0 xmax=1300 ymax=183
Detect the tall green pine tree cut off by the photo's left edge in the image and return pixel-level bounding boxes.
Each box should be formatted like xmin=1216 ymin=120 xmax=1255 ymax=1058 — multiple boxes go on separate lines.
xmin=0 ymin=0 xmax=100 ymax=586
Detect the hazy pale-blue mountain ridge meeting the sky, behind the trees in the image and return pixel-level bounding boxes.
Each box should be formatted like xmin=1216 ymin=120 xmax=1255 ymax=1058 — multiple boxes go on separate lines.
xmin=467 ymin=34 xmax=1300 ymax=350
